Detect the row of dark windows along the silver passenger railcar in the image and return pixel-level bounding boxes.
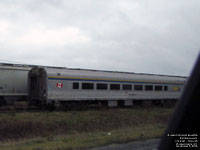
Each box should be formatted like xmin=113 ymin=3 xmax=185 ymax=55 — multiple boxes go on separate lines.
xmin=73 ymin=82 xmax=168 ymax=91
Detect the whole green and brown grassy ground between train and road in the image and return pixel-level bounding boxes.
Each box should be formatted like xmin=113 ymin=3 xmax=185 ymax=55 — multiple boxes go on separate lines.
xmin=0 ymin=107 xmax=173 ymax=150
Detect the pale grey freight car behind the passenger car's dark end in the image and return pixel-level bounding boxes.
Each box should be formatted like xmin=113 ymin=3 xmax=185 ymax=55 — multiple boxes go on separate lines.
xmin=0 ymin=64 xmax=31 ymax=105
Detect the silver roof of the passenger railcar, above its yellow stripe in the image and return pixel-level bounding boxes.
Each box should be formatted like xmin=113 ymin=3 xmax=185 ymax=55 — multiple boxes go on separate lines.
xmin=45 ymin=68 xmax=187 ymax=82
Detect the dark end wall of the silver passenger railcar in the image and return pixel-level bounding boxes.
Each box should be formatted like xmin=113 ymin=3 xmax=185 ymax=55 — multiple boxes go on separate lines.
xmin=29 ymin=68 xmax=47 ymax=104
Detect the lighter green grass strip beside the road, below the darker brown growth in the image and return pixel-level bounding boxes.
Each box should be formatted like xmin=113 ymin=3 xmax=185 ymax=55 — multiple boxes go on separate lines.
xmin=0 ymin=126 xmax=164 ymax=150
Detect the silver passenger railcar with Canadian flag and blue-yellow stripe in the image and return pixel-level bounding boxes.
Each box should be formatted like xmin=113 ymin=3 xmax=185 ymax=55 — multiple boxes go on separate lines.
xmin=28 ymin=68 xmax=186 ymax=106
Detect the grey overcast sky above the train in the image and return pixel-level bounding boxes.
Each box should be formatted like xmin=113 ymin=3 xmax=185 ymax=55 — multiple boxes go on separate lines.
xmin=0 ymin=0 xmax=200 ymax=75
